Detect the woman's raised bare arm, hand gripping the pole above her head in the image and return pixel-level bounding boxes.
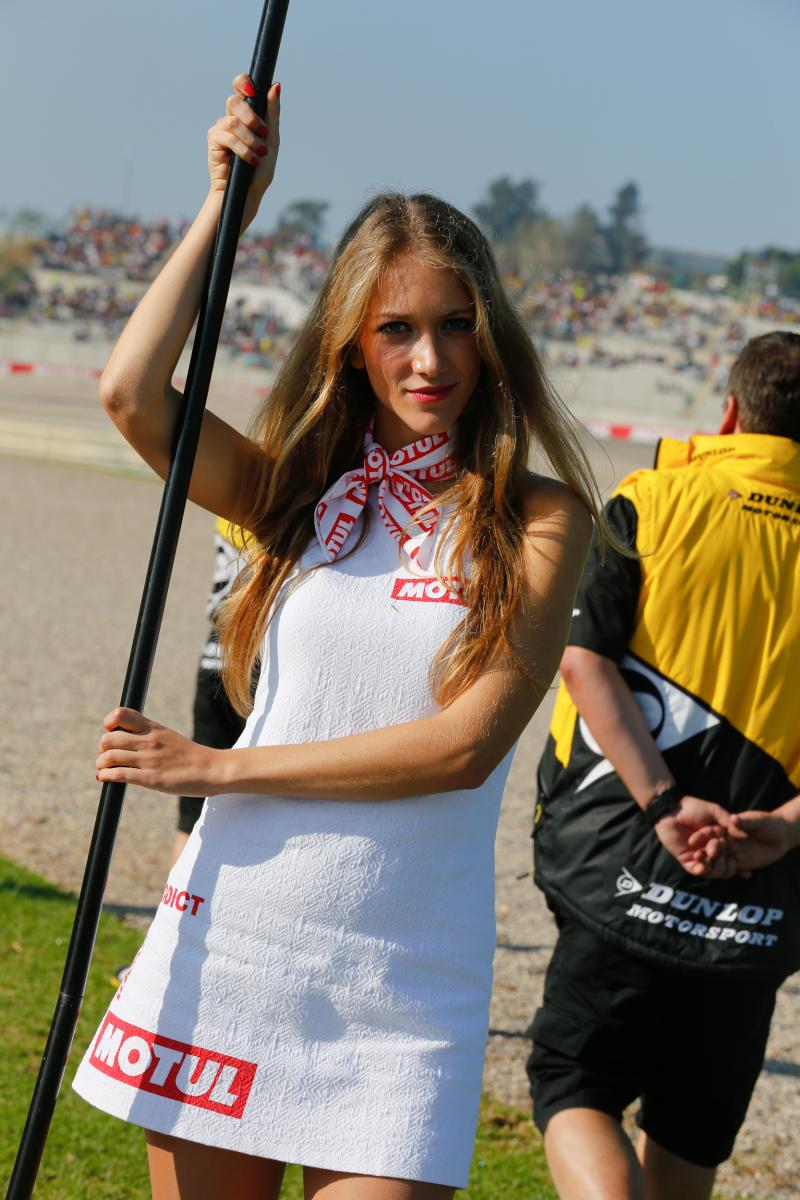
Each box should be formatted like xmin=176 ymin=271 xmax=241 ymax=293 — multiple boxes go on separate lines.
xmin=100 ymin=76 xmax=279 ymax=522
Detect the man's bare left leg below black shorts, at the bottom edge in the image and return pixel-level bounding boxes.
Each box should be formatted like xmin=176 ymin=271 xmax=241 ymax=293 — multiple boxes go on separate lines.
xmin=545 ymin=1109 xmax=642 ymax=1200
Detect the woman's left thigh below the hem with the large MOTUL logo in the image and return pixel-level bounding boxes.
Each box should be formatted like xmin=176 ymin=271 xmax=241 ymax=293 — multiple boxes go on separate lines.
xmin=145 ymin=1129 xmax=285 ymax=1200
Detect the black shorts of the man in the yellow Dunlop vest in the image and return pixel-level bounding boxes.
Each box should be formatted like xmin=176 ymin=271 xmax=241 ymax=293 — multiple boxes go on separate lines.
xmin=528 ymin=918 xmax=777 ymax=1166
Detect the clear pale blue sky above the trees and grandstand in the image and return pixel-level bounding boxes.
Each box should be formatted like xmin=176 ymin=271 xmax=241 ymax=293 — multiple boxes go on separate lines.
xmin=0 ymin=0 xmax=800 ymax=254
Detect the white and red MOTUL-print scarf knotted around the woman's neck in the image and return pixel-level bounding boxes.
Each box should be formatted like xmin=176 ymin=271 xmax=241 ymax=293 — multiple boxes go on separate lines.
xmin=314 ymin=426 xmax=458 ymax=564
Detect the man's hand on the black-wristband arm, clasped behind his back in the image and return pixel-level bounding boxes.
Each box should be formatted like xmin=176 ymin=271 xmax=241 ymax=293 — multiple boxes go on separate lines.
xmin=655 ymin=796 xmax=744 ymax=880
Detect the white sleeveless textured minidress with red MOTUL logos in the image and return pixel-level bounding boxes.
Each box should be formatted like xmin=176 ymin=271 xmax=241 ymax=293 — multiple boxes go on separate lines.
xmin=73 ymin=490 xmax=511 ymax=1187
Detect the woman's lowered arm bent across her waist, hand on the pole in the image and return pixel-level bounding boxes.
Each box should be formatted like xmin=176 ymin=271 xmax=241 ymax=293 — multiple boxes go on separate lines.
xmin=97 ymin=480 xmax=591 ymax=800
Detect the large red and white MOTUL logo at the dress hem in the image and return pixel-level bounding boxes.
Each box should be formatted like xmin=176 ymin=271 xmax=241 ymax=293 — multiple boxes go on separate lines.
xmin=89 ymin=1013 xmax=255 ymax=1118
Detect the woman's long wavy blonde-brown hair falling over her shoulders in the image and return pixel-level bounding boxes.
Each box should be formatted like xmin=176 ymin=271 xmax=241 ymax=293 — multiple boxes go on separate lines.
xmin=221 ymin=193 xmax=606 ymax=714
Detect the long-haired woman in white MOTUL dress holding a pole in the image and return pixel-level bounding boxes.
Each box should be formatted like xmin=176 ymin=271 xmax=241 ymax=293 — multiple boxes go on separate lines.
xmin=76 ymin=76 xmax=597 ymax=1200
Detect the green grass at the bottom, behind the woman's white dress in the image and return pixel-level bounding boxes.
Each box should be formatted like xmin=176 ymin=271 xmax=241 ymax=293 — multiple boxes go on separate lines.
xmin=0 ymin=859 xmax=555 ymax=1200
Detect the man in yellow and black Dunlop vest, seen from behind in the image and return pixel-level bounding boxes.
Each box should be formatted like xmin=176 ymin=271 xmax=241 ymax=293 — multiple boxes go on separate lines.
xmin=528 ymin=332 xmax=800 ymax=1200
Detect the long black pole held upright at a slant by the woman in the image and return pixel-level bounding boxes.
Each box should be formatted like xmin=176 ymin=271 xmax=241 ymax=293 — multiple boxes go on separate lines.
xmin=6 ymin=0 xmax=289 ymax=1200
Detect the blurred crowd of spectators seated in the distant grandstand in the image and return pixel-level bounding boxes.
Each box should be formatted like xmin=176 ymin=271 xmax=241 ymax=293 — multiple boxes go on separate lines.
xmin=0 ymin=206 xmax=800 ymax=376
